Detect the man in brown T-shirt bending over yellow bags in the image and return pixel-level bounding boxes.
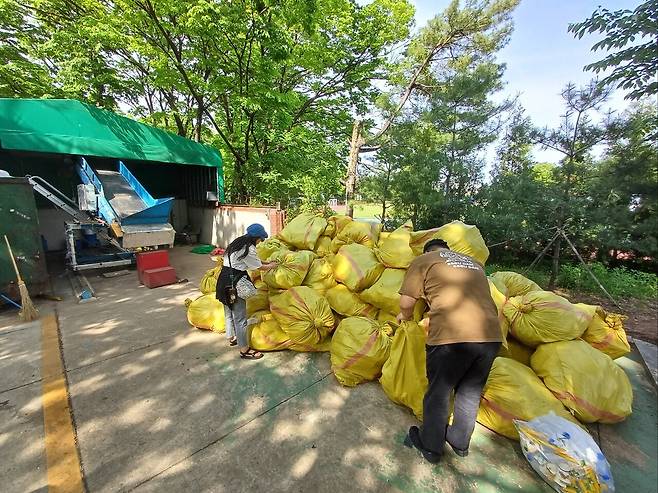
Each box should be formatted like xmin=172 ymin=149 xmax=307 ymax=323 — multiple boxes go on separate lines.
xmin=398 ymin=240 xmax=502 ymax=463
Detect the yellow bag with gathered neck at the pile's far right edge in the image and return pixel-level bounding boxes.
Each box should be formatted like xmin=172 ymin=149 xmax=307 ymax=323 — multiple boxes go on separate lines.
xmin=576 ymin=303 xmax=631 ymax=359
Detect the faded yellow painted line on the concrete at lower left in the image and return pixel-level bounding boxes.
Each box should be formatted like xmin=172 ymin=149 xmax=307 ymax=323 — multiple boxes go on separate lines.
xmin=41 ymin=314 xmax=85 ymax=493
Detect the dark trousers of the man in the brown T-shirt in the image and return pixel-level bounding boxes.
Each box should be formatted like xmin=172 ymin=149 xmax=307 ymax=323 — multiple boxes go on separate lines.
xmin=420 ymin=342 xmax=500 ymax=454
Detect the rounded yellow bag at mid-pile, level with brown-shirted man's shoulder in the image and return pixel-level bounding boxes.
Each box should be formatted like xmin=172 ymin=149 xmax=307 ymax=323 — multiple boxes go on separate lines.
xmin=332 ymin=243 xmax=385 ymax=293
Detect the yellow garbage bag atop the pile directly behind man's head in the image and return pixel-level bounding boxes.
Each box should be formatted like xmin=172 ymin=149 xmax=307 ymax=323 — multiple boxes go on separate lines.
xmin=409 ymin=221 xmax=489 ymax=265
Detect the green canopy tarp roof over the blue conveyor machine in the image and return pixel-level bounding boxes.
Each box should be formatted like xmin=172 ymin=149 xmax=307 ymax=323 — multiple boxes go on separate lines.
xmin=0 ymin=98 xmax=223 ymax=171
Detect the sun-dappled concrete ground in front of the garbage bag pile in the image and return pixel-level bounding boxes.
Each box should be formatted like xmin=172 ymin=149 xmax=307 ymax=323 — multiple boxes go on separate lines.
xmin=0 ymin=248 xmax=658 ymax=493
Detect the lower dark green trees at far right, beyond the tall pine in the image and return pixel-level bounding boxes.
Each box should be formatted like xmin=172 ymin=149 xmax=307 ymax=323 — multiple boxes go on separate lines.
xmin=476 ymin=92 xmax=658 ymax=274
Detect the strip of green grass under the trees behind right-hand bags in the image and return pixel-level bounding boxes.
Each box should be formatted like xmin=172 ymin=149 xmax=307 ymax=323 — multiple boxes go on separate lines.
xmin=486 ymin=262 xmax=658 ymax=299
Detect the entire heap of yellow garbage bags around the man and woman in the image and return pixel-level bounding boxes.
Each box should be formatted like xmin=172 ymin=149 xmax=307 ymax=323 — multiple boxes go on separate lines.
xmin=186 ymin=214 xmax=633 ymax=439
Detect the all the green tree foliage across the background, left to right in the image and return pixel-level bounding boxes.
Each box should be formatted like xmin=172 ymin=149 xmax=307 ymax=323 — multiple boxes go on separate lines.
xmin=0 ymin=0 xmax=658 ymax=278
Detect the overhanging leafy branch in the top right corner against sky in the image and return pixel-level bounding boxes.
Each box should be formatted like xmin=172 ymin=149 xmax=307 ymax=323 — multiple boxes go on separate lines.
xmin=569 ymin=0 xmax=658 ymax=100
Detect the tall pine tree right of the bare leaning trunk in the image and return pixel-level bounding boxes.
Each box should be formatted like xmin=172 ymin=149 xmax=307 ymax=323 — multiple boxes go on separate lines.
xmin=365 ymin=0 xmax=518 ymax=228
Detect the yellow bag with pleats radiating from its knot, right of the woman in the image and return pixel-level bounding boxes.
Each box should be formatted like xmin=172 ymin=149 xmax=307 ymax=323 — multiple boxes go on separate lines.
xmin=270 ymin=286 xmax=334 ymax=345
